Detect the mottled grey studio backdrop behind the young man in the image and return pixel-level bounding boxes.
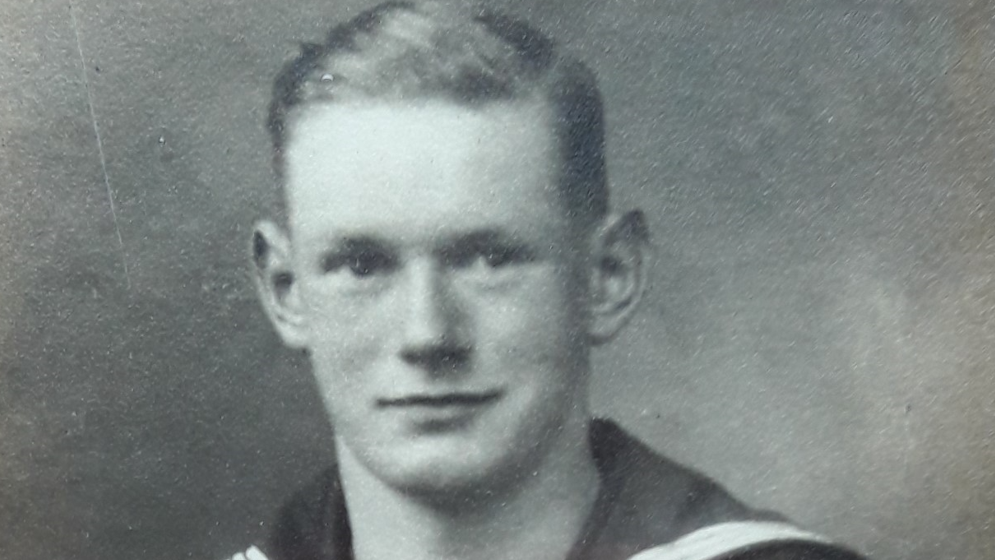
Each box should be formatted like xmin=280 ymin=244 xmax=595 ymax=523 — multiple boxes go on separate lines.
xmin=0 ymin=0 xmax=995 ymax=560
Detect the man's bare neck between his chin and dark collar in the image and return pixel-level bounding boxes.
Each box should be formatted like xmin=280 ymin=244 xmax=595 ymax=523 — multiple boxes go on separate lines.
xmin=339 ymin=419 xmax=599 ymax=560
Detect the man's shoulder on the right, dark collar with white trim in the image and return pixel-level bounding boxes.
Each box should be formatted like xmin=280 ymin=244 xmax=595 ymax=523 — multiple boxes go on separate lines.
xmin=592 ymin=420 xmax=860 ymax=560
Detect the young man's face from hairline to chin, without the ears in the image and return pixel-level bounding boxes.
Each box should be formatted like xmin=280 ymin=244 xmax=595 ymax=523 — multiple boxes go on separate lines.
xmin=276 ymin=102 xmax=588 ymax=491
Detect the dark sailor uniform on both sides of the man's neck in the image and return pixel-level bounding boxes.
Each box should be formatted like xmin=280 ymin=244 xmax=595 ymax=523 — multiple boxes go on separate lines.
xmin=265 ymin=420 xmax=860 ymax=560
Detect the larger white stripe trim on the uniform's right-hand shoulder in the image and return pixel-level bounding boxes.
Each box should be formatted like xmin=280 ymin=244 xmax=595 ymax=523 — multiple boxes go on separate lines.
xmin=629 ymin=521 xmax=830 ymax=560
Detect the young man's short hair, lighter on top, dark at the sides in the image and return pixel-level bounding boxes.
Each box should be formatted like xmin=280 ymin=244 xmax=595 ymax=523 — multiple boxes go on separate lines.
xmin=267 ymin=2 xmax=608 ymax=228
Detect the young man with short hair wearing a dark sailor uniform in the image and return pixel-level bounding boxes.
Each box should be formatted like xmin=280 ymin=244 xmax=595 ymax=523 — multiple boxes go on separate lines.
xmin=236 ymin=2 xmax=864 ymax=560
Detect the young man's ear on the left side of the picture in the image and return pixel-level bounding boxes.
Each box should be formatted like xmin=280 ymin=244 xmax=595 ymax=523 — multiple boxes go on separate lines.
xmin=252 ymin=220 xmax=307 ymax=349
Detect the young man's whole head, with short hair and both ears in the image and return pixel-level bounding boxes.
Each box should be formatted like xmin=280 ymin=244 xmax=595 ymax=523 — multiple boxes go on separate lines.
xmin=254 ymin=4 xmax=642 ymax=504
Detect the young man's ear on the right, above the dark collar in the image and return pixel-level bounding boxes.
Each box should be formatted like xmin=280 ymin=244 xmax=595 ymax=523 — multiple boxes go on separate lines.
xmin=588 ymin=210 xmax=648 ymax=344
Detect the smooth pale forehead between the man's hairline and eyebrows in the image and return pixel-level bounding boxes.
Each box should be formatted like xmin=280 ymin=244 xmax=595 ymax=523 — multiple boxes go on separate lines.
xmin=285 ymin=101 xmax=563 ymax=241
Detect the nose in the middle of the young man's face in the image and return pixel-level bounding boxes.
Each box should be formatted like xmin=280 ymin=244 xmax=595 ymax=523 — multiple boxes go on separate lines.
xmin=401 ymin=259 xmax=470 ymax=373
